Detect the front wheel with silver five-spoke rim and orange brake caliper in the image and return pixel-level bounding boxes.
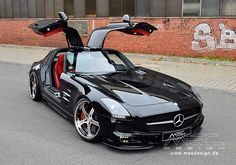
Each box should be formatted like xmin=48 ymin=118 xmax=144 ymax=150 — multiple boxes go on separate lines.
xmin=74 ymin=98 xmax=101 ymax=142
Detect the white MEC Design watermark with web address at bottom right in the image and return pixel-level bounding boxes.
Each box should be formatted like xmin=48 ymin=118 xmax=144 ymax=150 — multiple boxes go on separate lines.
xmin=164 ymin=128 xmax=225 ymax=156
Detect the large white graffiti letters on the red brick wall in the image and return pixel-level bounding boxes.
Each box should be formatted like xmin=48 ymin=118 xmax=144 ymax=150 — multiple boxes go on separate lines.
xmin=192 ymin=23 xmax=236 ymax=53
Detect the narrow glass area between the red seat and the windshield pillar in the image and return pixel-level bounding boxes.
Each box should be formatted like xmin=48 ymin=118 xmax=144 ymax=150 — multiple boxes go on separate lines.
xmin=66 ymin=52 xmax=76 ymax=73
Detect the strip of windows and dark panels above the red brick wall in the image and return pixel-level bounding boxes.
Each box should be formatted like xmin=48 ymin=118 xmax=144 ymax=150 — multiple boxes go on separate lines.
xmin=0 ymin=0 xmax=236 ymax=18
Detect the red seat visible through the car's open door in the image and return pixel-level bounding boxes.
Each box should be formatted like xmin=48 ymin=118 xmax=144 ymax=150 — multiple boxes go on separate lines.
xmin=54 ymin=54 xmax=64 ymax=89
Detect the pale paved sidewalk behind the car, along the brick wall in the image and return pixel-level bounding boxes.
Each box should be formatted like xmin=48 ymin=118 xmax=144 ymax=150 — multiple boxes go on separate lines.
xmin=0 ymin=45 xmax=236 ymax=92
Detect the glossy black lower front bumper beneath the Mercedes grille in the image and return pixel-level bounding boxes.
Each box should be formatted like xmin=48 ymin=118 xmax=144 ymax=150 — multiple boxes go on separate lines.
xmin=104 ymin=114 xmax=204 ymax=150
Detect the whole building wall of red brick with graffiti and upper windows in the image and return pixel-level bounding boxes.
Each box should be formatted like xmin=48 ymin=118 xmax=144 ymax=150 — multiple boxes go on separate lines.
xmin=0 ymin=0 xmax=236 ymax=60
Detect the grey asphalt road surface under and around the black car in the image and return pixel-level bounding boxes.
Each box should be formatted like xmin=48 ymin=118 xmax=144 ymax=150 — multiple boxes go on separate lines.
xmin=0 ymin=63 xmax=236 ymax=165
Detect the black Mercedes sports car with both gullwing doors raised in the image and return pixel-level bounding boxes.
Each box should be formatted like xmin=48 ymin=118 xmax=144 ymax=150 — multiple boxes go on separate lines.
xmin=29 ymin=12 xmax=204 ymax=150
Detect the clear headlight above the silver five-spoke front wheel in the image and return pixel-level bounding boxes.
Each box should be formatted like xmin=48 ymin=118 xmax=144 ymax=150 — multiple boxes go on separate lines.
xmin=101 ymin=98 xmax=130 ymax=119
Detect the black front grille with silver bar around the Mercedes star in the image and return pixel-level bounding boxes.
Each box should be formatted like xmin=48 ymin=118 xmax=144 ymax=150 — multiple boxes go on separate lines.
xmin=145 ymin=108 xmax=201 ymax=132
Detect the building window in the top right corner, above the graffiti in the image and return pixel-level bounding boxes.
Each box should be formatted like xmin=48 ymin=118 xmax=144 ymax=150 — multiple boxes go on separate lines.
xmin=220 ymin=0 xmax=236 ymax=16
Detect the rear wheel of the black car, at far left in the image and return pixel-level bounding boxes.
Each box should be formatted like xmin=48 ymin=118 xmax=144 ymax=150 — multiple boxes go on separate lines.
xmin=29 ymin=72 xmax=42 ymax=101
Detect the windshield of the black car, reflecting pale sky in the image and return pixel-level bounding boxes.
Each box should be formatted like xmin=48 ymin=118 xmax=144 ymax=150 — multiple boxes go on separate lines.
xmin=67 ymin=51 xmax=134 ymax=73
